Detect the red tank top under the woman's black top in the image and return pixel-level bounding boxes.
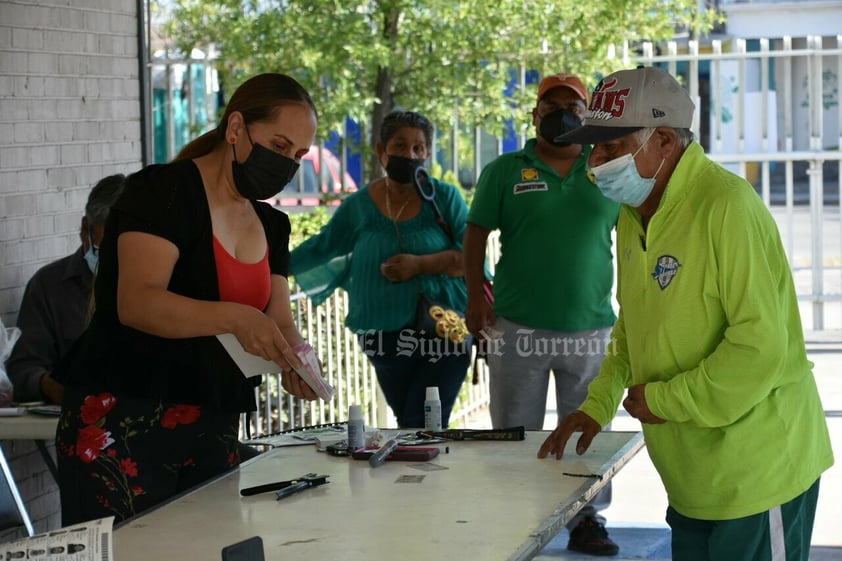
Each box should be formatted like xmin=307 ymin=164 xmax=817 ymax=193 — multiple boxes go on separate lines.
xmin=213 ymin=236 xmax=272 ymax=311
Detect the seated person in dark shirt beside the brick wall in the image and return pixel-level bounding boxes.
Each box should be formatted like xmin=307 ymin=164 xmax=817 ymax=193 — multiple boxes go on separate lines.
xmin=6 ymin=174 xmax=126 ymax=403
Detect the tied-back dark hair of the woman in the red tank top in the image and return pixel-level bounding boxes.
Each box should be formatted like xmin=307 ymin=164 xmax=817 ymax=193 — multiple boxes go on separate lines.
xmin=173 ymin=73 xmax=318 ymax=162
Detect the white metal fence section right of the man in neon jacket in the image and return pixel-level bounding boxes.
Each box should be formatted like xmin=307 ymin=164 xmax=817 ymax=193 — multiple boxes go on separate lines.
xmin=621 ymin=35 xmax=842 ymax=332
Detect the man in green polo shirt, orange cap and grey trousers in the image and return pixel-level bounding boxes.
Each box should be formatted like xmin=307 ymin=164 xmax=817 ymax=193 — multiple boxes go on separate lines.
xmin=464 ymin=74 xmax=619 ymax=555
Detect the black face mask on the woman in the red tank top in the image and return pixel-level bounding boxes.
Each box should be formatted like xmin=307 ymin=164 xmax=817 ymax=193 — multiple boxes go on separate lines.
xmin=231 ymin=130 xmax=299 ymax=201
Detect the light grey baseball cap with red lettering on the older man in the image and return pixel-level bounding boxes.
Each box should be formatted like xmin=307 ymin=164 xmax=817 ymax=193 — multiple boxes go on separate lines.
xmin=555 ymin=66 xmax=696 ymax=144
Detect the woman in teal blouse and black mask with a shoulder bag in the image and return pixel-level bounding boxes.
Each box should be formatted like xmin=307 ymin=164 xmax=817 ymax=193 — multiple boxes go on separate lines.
xmin=290 ymin=111 xmax=471 ymax=428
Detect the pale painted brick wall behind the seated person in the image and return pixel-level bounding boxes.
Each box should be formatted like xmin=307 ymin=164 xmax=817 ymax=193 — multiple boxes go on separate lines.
xmin=0 ymin=0 xmax=142 ymax=532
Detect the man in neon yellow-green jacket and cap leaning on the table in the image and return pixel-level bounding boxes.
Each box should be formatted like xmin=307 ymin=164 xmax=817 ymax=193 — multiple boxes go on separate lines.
xmin=538 ymin=68 xmax=833 ymax=561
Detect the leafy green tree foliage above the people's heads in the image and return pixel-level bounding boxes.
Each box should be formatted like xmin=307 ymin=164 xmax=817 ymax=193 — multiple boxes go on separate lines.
xmin=158 ymin=0 xmax=715 ymax=179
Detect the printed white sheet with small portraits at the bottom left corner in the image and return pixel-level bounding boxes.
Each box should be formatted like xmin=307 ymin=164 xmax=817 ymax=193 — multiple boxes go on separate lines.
xmin=0 ymin=516 xmax=114 ymax=561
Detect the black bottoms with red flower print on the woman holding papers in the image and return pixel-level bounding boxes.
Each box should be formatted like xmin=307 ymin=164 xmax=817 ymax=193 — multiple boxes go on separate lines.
xmin=56 ymin=388 xmax=240 ymax=526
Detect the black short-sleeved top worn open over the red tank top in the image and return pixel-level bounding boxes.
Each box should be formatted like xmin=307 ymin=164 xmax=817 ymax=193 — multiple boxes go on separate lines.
xmin=55 ymin=160 xmax=290 ymax=412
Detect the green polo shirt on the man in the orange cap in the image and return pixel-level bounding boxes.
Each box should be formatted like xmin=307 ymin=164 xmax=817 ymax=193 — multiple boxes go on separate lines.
xmin=468 ymin=139 xmax=619 ymax=331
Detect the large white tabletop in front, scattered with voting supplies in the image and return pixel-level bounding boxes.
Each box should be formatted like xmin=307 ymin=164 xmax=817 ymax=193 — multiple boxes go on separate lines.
xmin=114 ymin=432 xmax=643 ymax=561
